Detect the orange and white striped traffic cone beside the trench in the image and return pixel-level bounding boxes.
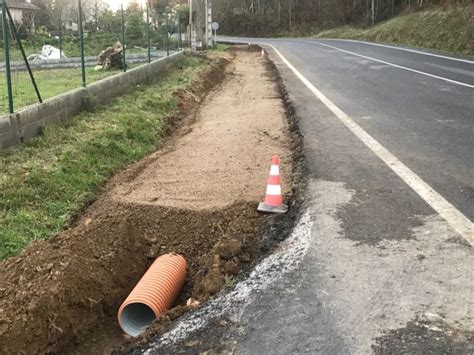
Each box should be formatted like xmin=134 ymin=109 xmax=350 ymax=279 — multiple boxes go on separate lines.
xmin=257 ymin=155 xmax=288 ymax=213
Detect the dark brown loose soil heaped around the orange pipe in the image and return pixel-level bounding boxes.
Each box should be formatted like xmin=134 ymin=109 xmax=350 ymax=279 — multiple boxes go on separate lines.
xmin=0 ymin=203 xmax=262 ymax=353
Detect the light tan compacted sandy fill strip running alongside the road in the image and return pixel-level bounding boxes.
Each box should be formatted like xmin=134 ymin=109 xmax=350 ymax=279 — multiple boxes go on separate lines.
xmin=114 ymin=51 xmax=291 ymax=210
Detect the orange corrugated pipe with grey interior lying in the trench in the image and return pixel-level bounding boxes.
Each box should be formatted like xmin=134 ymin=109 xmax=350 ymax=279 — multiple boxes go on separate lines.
xmin=117 ymin=254 xmax=186 ymax=337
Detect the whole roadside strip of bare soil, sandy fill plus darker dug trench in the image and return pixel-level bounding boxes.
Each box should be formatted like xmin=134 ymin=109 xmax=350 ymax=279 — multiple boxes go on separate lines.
xmin=0 ymin=47 xmax=293 ymax=354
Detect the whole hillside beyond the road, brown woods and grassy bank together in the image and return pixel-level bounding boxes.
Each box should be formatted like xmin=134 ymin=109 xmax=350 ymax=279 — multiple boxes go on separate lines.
xmin=213 ymin=0 xmax=474 ymax=55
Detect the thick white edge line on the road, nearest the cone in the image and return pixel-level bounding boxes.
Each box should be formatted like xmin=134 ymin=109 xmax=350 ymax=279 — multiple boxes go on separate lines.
xmin=270 ymin=44 xmax=474 ymax=245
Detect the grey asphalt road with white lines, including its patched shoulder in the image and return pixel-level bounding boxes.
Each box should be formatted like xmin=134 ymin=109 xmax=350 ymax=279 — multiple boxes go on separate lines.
xmin=131 ymin=38 xmax=474 ymax=354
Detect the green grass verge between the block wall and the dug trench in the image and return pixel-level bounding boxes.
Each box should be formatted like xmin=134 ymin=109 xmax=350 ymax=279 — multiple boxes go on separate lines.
xmin=0 ymin=57 xmax=211 ymax=260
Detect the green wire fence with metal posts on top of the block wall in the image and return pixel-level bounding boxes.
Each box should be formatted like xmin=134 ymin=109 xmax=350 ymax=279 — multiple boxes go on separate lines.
xmin=0 ymin=0 xmax=186 ymax=115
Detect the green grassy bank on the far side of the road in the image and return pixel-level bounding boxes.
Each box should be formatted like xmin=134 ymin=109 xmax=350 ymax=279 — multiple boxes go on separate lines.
xmin=317 ymin=4 xmax=474 ymax=55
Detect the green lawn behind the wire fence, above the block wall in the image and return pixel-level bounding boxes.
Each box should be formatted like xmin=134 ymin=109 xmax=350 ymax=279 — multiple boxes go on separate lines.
xmin=0 ymin=68 xmax=129 ymax=114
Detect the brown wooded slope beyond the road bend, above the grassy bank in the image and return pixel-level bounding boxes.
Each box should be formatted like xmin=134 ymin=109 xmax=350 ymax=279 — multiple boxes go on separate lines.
xmin=213 ymin=0 xmax=472 ymax=37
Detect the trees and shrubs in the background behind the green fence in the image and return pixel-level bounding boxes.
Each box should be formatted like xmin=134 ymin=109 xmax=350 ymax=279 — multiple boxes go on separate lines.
xmin=4 ymin=0 xmax=187 ymax=60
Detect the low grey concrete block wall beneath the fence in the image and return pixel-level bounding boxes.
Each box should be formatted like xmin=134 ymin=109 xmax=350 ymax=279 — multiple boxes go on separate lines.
xmin=0 ymin=52 xmax=184 ymax=150
